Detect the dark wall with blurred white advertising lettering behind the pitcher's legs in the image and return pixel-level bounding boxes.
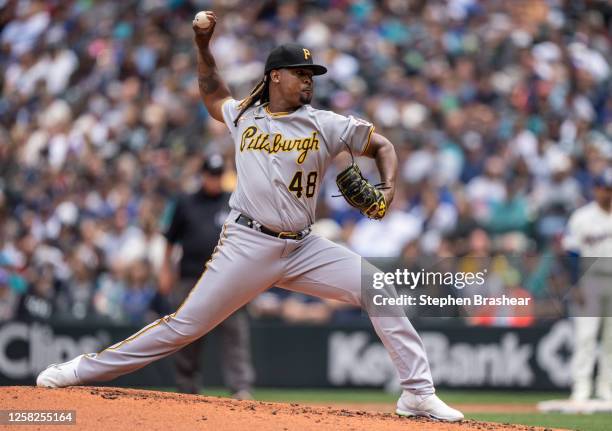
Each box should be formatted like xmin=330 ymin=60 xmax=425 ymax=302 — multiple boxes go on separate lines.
xmin=0 ymin=320 xmax=573 ymax=390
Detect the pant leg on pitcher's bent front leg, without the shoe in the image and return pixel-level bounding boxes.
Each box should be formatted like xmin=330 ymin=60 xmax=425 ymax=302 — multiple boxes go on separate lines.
xmin=279 ymin=236 xmax=435 ymax=395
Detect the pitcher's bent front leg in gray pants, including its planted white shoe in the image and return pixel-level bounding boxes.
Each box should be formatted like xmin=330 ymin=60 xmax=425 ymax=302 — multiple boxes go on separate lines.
xmin=278 ymin=236 xmax=463 ymax=422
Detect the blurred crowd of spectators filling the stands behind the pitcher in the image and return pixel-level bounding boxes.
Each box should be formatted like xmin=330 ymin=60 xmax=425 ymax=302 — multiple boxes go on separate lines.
xmin=0 ymin=0 xmax=612 ymax=322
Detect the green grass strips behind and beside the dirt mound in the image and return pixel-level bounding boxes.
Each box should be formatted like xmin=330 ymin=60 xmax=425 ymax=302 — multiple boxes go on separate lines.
xmin=149 ymin=388 xmax=612 ymax=431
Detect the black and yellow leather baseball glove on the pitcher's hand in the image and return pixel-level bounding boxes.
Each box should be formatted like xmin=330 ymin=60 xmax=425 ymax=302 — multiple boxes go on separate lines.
xmin=336 ymin=163 xmax=387 ymax=220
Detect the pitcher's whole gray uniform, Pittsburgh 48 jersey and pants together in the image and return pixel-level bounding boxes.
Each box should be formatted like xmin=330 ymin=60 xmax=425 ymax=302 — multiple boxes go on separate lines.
xmin=71 ymin=99 xmax=434 ymax=395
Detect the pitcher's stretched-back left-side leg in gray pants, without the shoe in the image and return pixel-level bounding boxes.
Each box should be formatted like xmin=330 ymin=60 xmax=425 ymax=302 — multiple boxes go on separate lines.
xmin=76 ymin=224 xmax=279 ymax=383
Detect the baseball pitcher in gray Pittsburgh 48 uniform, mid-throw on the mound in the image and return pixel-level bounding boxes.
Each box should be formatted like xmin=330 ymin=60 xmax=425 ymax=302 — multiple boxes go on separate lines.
xmin=37 ymin=12 xmax=463 ymax=421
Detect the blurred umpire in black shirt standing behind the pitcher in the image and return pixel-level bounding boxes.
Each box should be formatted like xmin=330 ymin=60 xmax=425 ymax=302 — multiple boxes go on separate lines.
xmin=159 ymin=154 xmax=255 ymax=399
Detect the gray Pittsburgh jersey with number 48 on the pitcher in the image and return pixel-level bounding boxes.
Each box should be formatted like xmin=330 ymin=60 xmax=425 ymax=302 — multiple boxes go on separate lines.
xmin=223 ymin=99 xmax=374 ymax=232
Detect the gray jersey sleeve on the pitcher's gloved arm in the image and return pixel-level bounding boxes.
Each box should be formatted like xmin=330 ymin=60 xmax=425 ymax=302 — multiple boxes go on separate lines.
xmin=329 ymin=115 xmax=374 ymax=156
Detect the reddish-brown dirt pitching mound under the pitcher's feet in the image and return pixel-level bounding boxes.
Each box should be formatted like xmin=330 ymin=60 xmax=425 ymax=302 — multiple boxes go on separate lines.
xmin=0 ymin=386 xmax=548 ymax=431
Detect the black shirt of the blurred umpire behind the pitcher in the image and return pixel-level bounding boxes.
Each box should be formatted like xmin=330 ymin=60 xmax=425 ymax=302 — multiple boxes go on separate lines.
xmin=166 ymin=189 xmax=231 ymax=278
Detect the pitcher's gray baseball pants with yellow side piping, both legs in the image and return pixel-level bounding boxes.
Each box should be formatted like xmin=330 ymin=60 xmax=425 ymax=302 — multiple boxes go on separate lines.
xmin=77 ymin=211 xmax=434 ymax=395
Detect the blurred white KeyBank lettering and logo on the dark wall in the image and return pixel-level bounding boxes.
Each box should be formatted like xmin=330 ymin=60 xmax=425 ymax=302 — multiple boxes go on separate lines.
xmin=328 ymin=320 xmax=573 ymax=390
